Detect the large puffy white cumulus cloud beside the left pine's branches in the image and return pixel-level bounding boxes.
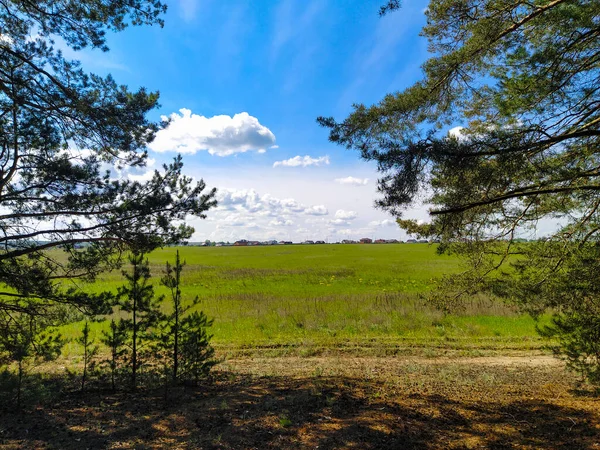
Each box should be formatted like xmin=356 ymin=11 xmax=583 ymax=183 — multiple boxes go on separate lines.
xmin=149 ymin=108 xmax=275 ymax=156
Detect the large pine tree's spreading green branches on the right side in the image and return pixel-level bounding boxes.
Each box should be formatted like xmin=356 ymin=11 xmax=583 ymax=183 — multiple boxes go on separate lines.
xmin=318 ymin=0 xmax=600 ymax=380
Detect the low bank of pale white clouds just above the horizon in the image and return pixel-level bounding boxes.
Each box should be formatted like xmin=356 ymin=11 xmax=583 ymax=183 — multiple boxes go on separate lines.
xmin=185 ymin=166 xmax=414 ymax=242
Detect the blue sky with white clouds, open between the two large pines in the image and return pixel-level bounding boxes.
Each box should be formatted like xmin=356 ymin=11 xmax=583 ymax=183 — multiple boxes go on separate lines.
xmin=67 ymin=0 xmax=427 ymax=241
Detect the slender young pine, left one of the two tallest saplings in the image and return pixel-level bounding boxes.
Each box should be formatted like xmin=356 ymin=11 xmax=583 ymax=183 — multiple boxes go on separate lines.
xmin=117 ymin=252 xmax=164 ymax=389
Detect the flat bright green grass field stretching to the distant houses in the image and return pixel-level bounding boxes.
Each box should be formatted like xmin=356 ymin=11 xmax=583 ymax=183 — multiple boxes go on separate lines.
xmin=64 ymin=244 xmax=541 ymax=355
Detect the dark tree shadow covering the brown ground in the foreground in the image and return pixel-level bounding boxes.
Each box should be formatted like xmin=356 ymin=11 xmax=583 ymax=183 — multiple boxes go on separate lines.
xmin=0 ymin=373 xmax=600 ymax=450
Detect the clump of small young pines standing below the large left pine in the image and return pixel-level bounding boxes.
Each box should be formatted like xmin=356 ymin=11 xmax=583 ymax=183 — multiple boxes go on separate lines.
xmin=97 ymin=252 xmax=216 ymax=392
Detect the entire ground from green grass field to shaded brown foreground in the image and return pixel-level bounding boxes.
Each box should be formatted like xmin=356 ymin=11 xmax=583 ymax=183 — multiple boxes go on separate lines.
xmin=0 ymin=244 xmax=600 ymax=450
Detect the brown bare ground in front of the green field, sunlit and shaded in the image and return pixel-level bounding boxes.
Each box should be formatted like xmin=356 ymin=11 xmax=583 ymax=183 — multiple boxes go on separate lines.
xmin=0 ymin=355 xmax=600 ymax=449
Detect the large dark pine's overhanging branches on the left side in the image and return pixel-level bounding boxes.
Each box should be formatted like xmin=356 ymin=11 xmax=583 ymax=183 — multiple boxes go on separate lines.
xmin=0 ymin=0 xmax=215 ymax=356
